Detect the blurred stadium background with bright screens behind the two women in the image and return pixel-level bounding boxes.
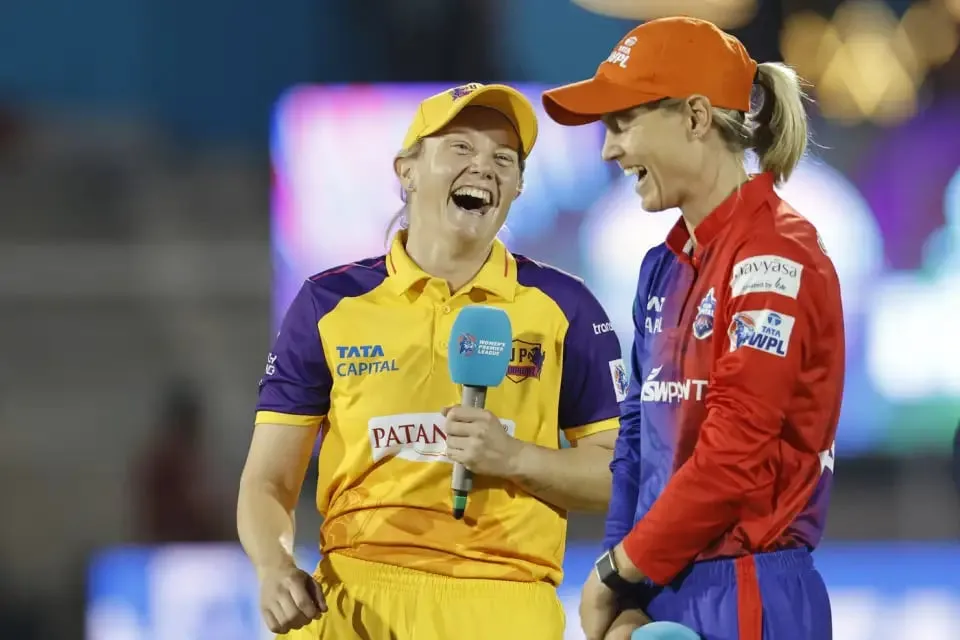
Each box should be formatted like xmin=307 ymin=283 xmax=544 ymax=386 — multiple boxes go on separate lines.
xmin=0 ymin=0 xmax=960 ymax=640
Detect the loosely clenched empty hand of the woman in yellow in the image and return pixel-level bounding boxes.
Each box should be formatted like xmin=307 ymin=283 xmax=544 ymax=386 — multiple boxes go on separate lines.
xmin=260 ymin=565 xmax=327 ymax=633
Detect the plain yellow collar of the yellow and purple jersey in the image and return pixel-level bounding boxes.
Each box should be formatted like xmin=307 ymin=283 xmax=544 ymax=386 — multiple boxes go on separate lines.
xmin=386 ymin=230 xmax=517 ymax=301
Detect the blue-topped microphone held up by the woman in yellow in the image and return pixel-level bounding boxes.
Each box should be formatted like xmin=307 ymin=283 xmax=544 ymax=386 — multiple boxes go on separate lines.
xmin=447 ymin=305 xmax=513 ymax=520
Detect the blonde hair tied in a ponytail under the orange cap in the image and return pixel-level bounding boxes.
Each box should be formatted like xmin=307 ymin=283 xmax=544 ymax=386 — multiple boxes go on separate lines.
xmin=659 ymin=62 xmax=809 ymax=185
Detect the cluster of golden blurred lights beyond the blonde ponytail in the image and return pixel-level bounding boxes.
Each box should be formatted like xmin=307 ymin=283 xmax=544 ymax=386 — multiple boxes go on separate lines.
xmin=781 ymin=0 xmax=960 ymax=124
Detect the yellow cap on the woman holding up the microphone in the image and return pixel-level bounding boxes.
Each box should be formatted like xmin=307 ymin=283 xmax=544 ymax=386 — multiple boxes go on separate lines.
xmin=403 ymin=82 xmax=537 ymax=158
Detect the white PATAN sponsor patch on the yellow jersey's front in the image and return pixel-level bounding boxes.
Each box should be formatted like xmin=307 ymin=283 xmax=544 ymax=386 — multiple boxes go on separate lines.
xmin=367 ymin=413 xmax=517 ymax=462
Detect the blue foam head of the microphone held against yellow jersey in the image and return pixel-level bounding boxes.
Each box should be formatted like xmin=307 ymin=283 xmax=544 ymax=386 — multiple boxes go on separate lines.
xmin=447 ymin=304 xmax=513 ymax=387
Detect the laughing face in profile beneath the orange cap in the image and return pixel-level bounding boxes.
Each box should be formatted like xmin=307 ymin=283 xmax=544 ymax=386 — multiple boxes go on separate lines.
xmin=603 ymin=98 xmax=715 ymax=212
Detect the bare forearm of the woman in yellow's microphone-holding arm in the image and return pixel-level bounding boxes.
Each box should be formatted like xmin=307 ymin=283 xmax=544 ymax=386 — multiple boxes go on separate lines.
xmin=512 ymin=444 xmax=613 ymax=512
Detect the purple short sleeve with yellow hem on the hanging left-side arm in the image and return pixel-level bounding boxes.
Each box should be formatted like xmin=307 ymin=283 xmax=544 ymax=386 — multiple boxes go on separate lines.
xmin=256 ymin=282 xmax=333 ymax=426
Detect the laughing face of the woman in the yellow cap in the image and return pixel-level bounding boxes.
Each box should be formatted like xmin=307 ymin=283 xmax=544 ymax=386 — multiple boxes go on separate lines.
xmin=394 ymin=107 xmax=521 ymax=244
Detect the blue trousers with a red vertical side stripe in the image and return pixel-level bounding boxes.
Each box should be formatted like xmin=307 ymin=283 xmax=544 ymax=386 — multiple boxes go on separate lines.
xmin=631 ymin=549 xmax=833 ymax=640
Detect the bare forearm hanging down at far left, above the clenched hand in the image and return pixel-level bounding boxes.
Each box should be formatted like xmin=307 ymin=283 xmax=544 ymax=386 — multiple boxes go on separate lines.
xmin=237 ymin=481 xmax=295 ymax=574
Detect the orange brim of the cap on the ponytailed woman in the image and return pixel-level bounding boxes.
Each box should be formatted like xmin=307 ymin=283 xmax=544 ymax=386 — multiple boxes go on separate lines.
xmin=543 ymin=77 xmax=664 ymax=127
